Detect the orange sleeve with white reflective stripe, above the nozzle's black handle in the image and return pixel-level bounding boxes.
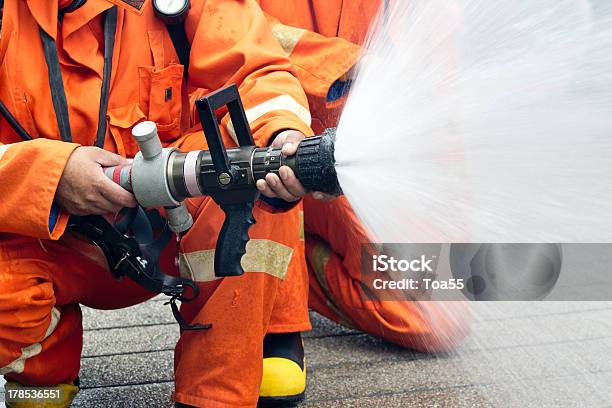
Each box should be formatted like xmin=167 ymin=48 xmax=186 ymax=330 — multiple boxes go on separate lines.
xmin=185 ymin=0 xmax=312 ymax=146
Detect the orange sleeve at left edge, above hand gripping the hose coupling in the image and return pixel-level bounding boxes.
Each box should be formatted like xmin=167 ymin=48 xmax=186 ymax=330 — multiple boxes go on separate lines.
xmin=0 ymin=139 xmax=79 ymax=239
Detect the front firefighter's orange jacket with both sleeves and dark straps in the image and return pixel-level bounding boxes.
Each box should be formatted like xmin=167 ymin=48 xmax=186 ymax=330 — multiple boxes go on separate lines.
xmin=0 ymin=0 xmax=311 ymax=239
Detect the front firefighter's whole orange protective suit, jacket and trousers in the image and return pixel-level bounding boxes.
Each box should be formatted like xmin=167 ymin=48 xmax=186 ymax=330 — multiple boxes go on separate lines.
xmin=0 ymin=0 xmax=311 ymax=407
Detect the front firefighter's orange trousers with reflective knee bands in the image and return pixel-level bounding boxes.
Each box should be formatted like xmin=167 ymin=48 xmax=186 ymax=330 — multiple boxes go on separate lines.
xmin=0 ymin=141 xmax=310 ymax=407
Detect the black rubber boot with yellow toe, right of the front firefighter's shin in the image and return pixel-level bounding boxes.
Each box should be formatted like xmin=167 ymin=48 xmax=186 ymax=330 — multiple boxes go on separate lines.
xmin=258 ymin=333 xmax=306 ymax=407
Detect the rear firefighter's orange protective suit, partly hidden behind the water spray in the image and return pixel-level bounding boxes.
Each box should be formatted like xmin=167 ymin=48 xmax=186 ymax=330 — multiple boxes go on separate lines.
xmin=259 ymin=0 xmax=471 ymax=351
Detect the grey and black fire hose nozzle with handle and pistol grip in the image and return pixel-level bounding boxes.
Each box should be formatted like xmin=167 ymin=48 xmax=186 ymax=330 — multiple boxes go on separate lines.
xmin=105 ymin=85 xmax=342 ymax=277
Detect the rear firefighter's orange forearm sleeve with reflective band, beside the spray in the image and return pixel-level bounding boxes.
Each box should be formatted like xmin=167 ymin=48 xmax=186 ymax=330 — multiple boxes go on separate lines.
xmin=266 ymin=15 xmax=361 ymax=98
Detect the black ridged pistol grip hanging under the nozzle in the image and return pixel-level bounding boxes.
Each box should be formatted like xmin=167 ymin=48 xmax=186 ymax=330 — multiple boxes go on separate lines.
xmin=215 ymin=202 xmax=255 ymax=277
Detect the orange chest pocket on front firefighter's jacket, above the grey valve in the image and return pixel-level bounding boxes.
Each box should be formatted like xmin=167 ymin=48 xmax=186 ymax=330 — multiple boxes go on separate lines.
xmin=138 ymin=64 xmax=183 ymax=142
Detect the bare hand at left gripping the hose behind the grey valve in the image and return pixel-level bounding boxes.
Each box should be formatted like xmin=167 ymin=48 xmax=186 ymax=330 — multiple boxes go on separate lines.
xmin=55 ymin=147 xmax=138 ymax=215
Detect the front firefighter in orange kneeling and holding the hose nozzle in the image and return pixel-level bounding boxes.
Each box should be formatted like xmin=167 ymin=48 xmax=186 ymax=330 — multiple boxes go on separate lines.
xmin=0 ymin=0 xmax=328 ymax=407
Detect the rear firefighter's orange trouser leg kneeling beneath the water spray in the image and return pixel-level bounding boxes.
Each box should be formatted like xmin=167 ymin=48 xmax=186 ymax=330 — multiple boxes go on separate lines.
xmin=304 ymin=197 xmax=472 ymax=352
